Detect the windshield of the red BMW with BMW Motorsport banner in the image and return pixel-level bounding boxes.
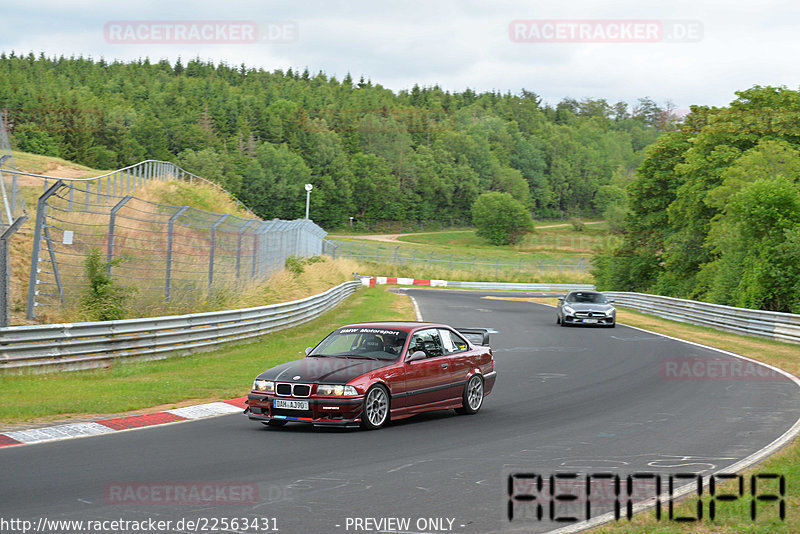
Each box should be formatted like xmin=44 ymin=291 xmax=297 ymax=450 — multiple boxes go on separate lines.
xmin=309 ymin=327 xmax=408 ymax=360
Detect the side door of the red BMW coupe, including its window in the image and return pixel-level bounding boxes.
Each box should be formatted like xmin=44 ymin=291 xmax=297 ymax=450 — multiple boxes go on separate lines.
xmin=402 ymin=328 xmax=451 ymax=411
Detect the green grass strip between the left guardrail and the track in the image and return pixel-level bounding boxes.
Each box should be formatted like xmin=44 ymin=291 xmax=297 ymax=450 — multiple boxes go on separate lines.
xmin=0 ymin=288 xmax=414 ymax=423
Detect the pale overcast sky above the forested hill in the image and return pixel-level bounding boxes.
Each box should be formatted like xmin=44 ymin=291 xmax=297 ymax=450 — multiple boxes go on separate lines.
xmin=0 ymin=0 xmax=800 ymax=109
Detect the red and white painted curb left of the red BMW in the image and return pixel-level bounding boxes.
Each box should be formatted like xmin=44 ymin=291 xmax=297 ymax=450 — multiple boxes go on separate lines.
xmin=0 ymin=397 xmax=247 ymax=447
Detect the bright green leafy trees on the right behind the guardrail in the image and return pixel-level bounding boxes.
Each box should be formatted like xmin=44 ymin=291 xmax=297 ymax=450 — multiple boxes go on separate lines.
xmin=594 ymin=86 xmax=800 ymax=313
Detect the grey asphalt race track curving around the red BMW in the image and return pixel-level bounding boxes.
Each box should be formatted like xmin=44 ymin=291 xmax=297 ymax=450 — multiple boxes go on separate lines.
xmin=0 ymin=289 xmax=800 ymax=533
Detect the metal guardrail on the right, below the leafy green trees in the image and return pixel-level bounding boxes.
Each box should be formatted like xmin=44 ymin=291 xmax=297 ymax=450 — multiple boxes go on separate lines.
xmin=603 ymin=291 xmax=800 ymax=343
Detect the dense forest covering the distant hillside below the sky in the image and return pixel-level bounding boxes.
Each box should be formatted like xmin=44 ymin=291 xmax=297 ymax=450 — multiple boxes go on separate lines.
xmin=0 ymin=52 xmax=664 ymax=229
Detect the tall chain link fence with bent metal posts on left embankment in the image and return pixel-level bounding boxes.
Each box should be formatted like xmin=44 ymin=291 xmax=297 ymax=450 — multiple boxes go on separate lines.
xmin=27 ymin=180 xmax=326 ymax=318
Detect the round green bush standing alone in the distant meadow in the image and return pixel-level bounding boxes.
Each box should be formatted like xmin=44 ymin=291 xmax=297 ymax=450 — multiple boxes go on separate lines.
xmin=472 ymin=192 xmax=533 ymax=245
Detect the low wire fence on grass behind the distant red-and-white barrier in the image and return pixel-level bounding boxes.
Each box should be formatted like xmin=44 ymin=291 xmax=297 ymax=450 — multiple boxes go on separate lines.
xmin=323 ymin=239 xmax=591 ymax=276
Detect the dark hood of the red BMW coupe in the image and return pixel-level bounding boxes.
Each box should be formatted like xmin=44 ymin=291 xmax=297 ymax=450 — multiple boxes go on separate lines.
xmin=258 ymin=356 xmax=395 ymax=384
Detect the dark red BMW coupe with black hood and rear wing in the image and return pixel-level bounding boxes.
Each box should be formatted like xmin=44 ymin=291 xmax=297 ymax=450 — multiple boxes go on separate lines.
xmin=245 ymin=322 xmax=497 ymax=429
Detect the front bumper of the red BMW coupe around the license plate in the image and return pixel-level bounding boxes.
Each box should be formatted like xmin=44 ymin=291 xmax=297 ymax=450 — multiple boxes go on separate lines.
xmin=245 ymin=392 xmax=364 ymax=427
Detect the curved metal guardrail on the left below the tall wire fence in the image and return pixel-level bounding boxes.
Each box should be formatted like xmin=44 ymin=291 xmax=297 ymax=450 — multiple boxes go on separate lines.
xmin=0 ymin=281 xmax=361 ymax=372
